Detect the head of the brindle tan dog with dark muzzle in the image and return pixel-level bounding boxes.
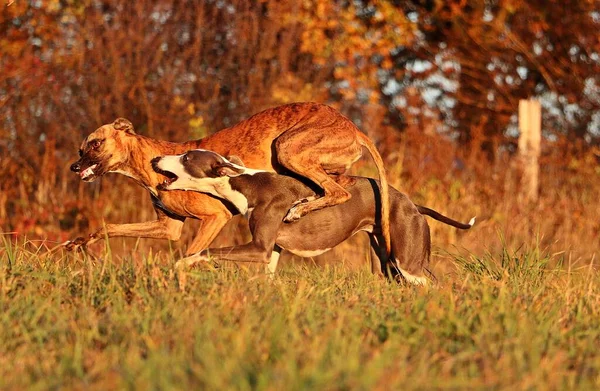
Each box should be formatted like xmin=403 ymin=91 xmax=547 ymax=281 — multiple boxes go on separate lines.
xmin=71 ymin=118 xmax=135 ymax=182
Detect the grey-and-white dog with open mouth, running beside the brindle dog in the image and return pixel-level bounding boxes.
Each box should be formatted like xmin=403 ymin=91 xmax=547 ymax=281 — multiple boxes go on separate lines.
xmin=152 ymin=150 xmax=475 ymax=285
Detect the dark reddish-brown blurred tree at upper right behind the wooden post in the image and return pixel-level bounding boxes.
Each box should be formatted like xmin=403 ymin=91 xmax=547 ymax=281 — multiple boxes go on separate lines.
xmin=397 ymin=0 xmax=600 ymax=152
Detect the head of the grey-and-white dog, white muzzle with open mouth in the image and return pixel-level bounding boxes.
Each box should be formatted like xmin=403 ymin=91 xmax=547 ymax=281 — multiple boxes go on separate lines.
xmin=152 ymin=149 xmax=247 ymax=192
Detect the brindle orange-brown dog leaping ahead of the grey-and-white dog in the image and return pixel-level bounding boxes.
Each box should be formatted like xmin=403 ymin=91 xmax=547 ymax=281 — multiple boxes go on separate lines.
xmin=64 ymin=103 xmax=389 ymax=254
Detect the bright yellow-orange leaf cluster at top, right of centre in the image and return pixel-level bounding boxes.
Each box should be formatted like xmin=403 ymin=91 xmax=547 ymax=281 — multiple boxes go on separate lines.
xmin=286 ymin=0 xmax=416 ymax=103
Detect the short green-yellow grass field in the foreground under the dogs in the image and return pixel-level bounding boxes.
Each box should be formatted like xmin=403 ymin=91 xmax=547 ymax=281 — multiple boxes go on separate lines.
xmin=0 ymin=242 xmax=600 ymax=390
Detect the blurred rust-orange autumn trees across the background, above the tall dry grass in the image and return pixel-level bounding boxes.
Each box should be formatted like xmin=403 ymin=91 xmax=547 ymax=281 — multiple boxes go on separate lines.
xmin=0 ymin=0 xmax=600 ymax=243
